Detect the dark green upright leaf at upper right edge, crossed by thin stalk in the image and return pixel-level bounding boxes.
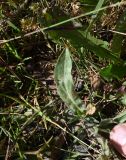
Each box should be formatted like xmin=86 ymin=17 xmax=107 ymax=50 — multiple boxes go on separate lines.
xmin=112 ymin=10 xmax=126 ymax=57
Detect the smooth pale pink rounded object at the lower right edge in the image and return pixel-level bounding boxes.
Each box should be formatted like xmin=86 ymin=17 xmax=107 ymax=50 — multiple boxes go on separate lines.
xmin=110 ymin=123 xmax=126 ymax=158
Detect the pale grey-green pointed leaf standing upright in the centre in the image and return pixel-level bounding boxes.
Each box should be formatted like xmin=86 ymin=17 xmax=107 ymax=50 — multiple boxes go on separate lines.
xmin=54 ymin=48 xmax=84 ymax=113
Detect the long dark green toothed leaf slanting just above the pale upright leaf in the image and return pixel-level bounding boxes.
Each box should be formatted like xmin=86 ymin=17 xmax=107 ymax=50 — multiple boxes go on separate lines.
xmin=48 ymin=26 xmax=119 ymax=62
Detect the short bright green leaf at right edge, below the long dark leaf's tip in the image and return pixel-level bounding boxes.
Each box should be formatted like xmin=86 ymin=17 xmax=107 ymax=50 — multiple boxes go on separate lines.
xmin=100 ymin=64 xmax=126 ymax=80
